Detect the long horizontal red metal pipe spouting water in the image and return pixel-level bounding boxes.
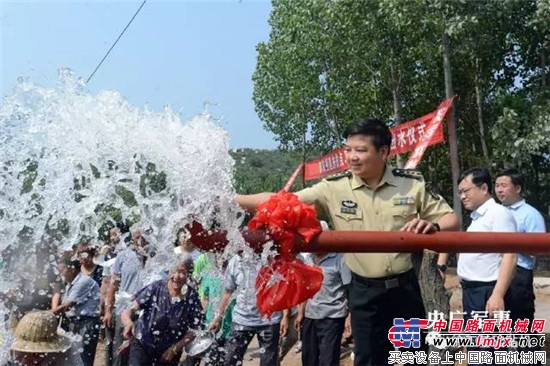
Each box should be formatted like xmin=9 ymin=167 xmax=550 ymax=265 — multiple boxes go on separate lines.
xmin=186 ymin=222 xmax=550 ymax=254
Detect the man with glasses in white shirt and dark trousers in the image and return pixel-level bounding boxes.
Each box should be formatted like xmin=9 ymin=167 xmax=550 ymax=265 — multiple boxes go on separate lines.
xmin=457 ymin=168 xmax=518 ymax=366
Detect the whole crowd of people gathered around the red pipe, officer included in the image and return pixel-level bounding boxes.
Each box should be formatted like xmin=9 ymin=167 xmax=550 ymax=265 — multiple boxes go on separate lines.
xmin=5 ymin=119 xmax=546 ymax=366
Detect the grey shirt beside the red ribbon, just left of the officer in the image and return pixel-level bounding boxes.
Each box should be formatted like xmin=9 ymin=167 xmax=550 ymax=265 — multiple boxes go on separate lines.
xmin=304 ymin=253 xmax=351 ymax=319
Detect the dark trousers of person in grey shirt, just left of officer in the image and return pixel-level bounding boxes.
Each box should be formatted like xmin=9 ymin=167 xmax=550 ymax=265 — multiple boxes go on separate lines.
xmin=301 ymin=318 xmax=346 ymax=366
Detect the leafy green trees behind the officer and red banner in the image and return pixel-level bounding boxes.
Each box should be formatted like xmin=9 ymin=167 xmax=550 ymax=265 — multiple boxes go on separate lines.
xmin=253 ymin=0 xmax=550 ymax=226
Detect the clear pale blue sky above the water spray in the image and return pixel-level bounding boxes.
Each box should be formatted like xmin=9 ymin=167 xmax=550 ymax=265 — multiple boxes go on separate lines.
xmin=0 ymin=0 xmax=277 ymax=148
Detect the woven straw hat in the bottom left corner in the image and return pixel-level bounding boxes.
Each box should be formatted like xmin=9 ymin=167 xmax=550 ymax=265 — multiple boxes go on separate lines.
xmin=11 ymin=311 xmax=71 ymax=353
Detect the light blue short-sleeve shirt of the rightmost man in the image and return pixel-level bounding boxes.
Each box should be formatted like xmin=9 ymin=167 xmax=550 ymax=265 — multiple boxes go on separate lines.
xmin=506 ymin=200 xmax=546 ymax=270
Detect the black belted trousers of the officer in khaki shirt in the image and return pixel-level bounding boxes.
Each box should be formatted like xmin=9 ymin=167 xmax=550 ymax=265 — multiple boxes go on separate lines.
xmin=348 ymin=269 xmax=428 ymax=366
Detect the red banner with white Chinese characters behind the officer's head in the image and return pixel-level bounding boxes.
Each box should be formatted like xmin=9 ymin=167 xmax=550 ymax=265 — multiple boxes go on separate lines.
xmin=304 ymin=98 xmax=453 ymax=180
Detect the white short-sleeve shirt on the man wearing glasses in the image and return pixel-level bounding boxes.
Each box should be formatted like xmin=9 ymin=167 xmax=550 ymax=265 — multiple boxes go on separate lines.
xmin=457 ymin=198 xmax=516 ymax=282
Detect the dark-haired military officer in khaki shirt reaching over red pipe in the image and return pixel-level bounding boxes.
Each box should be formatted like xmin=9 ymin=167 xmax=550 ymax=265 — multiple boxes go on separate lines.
xmin=235 ymin=119 xmax=459 ymax=366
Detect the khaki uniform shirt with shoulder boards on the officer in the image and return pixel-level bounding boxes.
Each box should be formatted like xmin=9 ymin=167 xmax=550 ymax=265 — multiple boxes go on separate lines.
xmin=296 ymin=166 xmax=453 ymax=278
